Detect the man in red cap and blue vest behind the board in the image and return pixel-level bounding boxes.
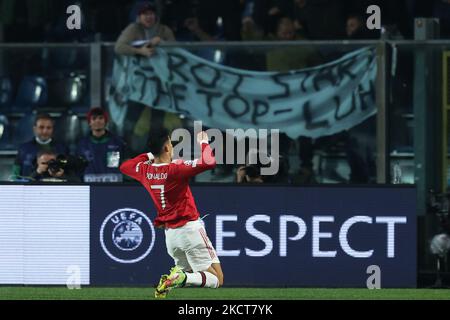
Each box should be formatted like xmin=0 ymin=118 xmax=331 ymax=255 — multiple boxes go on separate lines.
xmin=76 ymin=108 xmax=125 ymax=182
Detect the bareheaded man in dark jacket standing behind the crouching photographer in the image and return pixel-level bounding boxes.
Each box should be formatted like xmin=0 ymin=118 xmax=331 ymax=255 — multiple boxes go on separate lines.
xmin=13 ymin=113 xmax=68 ymax=179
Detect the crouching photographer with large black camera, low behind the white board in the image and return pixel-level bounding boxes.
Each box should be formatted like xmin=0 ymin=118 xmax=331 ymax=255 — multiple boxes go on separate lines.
xmin=31 ymin=151 xmax=86 ymax=182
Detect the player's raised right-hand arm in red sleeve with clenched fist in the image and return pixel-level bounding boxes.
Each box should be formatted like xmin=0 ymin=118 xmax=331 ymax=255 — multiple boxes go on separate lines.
xmin=173 ymin=142 xmax=216 ymax=178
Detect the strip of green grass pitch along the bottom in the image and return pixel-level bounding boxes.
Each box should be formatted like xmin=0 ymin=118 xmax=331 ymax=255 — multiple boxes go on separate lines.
xmin=0 ymin=287 xmax=450 ymax=300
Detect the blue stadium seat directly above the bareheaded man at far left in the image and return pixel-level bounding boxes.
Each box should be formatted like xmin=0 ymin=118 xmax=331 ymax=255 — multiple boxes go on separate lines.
xmin=12 ymin=76 xmax=48 ymax=112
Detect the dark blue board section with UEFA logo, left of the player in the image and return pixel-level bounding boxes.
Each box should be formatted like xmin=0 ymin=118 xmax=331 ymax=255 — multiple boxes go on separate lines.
xmin=90 ymin=186 xmax=172 ymax=286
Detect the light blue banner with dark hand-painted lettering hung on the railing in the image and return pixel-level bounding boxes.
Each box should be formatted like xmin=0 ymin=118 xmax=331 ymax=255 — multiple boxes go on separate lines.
xmin=109 ymin=48 xmax=377 ymax=138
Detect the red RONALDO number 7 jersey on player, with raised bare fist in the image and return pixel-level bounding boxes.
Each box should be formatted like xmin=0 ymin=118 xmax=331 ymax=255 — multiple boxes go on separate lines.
xmin=120 ymin=142 xmax=216 ymax=228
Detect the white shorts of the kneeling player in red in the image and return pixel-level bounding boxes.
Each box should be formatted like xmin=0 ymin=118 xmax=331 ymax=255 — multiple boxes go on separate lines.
xmin=166 ymin=219 xmax=220 ymax=272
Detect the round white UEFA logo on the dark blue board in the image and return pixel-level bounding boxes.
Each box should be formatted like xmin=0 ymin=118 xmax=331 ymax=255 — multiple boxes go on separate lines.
xmin=100 ymin=208 xmax=155 ymax=263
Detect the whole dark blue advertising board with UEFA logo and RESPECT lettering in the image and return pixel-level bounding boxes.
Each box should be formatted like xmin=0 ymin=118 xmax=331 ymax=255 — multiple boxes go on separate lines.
xmin=91 ymin=185 xmax=417 ymax=287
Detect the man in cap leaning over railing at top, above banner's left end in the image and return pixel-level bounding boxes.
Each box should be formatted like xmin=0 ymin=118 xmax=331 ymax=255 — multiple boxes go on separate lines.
xmin=115 ymin=2 xmax=175 ymax=57
